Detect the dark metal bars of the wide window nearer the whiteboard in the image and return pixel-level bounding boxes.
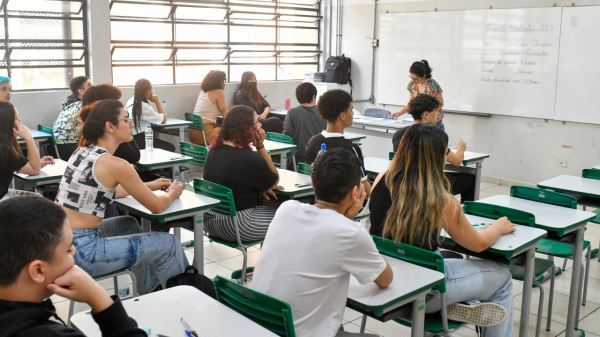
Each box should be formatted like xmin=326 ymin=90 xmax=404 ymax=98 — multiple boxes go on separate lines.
xmin=109 ymin=0 xmax=323 ymax=84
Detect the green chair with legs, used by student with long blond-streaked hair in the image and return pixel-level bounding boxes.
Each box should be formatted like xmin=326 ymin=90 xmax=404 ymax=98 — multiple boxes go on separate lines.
xmin=370 ymin=236 xmax=465 ymax=335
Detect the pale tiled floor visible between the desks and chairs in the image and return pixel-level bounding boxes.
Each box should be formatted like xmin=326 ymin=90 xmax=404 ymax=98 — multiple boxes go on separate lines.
xmin=53 ymin=178 xmax=600 ymax=337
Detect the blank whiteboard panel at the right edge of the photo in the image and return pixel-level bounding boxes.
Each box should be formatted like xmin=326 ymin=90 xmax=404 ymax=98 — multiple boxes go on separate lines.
xmin=554 ymin=6 xmax=600 ymax=124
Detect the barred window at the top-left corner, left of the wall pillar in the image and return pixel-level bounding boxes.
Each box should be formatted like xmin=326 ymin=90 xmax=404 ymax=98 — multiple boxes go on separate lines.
xmin=0 ymin=0 xmax=88 ymax=90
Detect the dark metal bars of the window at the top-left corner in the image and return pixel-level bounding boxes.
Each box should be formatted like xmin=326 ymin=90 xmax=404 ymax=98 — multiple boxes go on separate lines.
xmin=0 ymin=0 xmax=90 ymax=92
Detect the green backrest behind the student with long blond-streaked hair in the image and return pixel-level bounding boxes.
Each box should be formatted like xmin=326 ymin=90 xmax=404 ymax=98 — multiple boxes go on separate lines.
xmin=372 ymin=235 xmax=446 ymax=293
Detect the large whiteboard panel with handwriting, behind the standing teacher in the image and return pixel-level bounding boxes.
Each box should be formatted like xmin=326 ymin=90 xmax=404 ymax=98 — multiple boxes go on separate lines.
xmin=378 ymin=7 xmax=561 ymax=119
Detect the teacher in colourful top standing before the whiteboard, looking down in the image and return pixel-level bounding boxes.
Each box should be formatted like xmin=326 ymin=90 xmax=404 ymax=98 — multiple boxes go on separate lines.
xmin=390 ymin=60 xmax=444 ymax=130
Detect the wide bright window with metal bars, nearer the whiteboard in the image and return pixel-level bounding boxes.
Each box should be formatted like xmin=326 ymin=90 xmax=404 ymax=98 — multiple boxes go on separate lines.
xmin=110 ymin=0 xmax=322 ymax=85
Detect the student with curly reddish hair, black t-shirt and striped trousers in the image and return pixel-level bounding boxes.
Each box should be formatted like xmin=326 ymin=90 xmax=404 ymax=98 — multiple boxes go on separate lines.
xmin=204 ymin=105 xmax=282 ymax=241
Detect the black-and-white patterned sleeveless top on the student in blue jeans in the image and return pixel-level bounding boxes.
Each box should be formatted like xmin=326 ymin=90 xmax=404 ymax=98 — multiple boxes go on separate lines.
xmin=56 ymin=145 xmax=117 ymax=218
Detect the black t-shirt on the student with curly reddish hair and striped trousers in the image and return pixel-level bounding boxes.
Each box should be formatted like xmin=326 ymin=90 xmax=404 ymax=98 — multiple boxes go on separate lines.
xmin=204 ymin=145 xmax=278 ymax=211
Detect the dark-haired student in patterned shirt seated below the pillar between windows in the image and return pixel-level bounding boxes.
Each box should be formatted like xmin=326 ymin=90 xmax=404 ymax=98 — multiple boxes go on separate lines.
xmin=52 ymin=76 xmax=92 ymax=160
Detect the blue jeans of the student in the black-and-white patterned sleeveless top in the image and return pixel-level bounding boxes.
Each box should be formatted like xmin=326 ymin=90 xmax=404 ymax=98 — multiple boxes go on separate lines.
xmin=73 ymin=217 xmax=189 ymax=295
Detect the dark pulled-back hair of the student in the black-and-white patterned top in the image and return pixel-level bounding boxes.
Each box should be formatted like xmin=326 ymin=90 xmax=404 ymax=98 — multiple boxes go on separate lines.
xmin=78 ymin=99 xmax=124 ymax=147
